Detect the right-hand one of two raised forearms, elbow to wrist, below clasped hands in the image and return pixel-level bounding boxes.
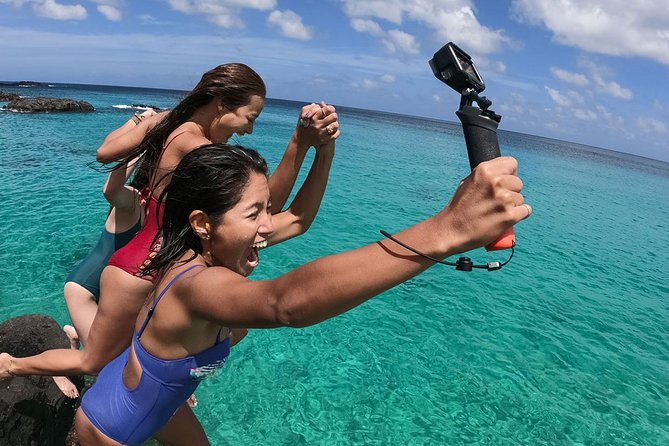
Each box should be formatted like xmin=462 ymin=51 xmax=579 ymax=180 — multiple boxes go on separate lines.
xmin=268 ymin=141 xmax=335 ymax=245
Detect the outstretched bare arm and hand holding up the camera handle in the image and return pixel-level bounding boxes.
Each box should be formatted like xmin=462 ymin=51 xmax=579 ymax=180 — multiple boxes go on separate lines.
xmin=184 ymin=157 xmax=531 ymax=328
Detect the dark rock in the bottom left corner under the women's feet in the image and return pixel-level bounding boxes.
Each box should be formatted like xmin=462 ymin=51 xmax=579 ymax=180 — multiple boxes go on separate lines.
xmin=0 ymin=314 xmax=84 ymax=445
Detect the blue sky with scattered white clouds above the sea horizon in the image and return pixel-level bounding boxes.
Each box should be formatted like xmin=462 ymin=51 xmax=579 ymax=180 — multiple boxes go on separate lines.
xmin=0 ymin=0 xmax=669 ymax=161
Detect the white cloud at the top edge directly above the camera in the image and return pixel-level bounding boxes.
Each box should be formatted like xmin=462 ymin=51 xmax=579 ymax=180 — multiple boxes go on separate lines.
xmin=343 ymin=0 xmax=512 ymax=55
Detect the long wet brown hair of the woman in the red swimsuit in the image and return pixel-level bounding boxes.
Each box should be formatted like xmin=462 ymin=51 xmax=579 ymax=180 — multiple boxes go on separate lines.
xmin=118 ymin=63 xmax=266 ymax=190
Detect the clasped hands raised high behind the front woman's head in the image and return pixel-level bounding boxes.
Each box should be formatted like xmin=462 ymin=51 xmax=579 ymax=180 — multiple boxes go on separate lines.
xmin=295 ymin=102 xmax=340 ymax=147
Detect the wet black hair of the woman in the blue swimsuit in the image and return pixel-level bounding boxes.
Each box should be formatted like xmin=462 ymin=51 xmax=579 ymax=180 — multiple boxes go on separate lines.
xmin=144 ymin=144 xmax=267 ymax=283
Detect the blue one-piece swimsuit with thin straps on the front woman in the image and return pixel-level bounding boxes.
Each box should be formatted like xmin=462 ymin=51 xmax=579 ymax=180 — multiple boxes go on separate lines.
xmin=81 ymin=265 xmax=230 ymax=445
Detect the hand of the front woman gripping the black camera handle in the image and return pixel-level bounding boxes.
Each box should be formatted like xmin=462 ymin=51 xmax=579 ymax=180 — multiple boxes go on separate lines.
xmin=434 ymin=157 xmax=532 ymax=255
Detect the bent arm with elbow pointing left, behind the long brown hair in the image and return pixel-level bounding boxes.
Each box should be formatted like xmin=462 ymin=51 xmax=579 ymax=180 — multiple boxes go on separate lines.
xmin=95 ymin=111 xmax=169 ymax=164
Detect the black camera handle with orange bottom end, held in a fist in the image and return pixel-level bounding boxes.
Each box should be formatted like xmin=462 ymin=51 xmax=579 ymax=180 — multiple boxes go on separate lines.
xmin=455 ymin=90 xmax=516 ymax=251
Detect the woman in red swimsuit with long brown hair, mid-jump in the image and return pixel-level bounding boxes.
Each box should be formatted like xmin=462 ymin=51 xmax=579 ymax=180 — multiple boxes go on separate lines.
xmin=0 ymin=64 xmax=339 ymax=444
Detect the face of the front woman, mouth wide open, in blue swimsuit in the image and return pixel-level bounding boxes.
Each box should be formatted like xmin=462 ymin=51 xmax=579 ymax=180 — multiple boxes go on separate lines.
xmin=211 ymin=172 xmax=274 ymax=276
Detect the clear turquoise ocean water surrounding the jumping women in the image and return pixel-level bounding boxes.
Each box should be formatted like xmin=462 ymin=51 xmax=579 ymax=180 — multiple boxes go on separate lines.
xmin=0 ymin=84 xmax=669 ymax=445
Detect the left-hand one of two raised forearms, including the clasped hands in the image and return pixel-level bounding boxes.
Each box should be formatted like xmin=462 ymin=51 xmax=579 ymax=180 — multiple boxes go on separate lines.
xmin=269 ymin=103 xmax=339 ymax=213
